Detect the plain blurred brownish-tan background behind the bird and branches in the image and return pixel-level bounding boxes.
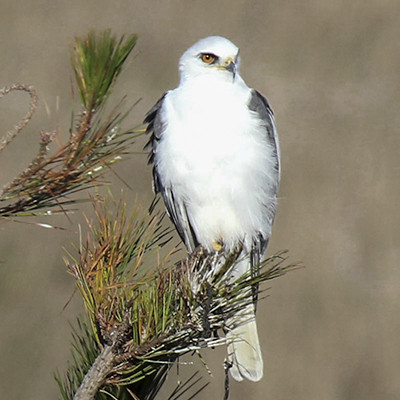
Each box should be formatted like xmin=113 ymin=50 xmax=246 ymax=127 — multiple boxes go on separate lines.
xmin=0 ymin=0 xmax=400 ymax=400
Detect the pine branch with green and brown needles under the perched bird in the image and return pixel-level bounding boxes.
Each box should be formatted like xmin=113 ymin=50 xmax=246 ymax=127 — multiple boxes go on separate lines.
xmin=59 ymin=197 xmax=294 ymax=400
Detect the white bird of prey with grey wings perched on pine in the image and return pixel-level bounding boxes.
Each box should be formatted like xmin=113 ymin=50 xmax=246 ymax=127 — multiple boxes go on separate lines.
xmin=144 ymin=36 xmax=280 ymax=382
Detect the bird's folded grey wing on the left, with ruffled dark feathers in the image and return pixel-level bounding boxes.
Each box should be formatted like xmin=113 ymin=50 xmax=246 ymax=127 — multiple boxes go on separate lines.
xmin=144 ymin=93 xmax=199 ymax=252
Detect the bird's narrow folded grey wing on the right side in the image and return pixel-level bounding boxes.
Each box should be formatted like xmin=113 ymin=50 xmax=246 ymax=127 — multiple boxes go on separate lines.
xmin=248 ymin=89 xmax=280 ymax=304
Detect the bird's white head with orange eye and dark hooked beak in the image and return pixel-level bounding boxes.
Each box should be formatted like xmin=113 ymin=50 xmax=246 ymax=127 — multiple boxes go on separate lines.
xmin=179 ymin=36 xmax=240 ymax=81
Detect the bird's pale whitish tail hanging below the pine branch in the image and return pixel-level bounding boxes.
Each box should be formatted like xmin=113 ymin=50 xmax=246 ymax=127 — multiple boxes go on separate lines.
xmin=226 ymin=304 xmax=264 ymax=382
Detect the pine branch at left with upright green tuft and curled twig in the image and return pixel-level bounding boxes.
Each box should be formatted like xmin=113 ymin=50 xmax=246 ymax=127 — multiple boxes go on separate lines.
xmin=0 ymin=31 xmax=141 ymax=220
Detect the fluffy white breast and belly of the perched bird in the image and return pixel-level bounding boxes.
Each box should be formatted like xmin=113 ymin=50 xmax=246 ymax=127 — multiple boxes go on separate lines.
xmin=156 ymin=78 xmax=274 ymax=248
